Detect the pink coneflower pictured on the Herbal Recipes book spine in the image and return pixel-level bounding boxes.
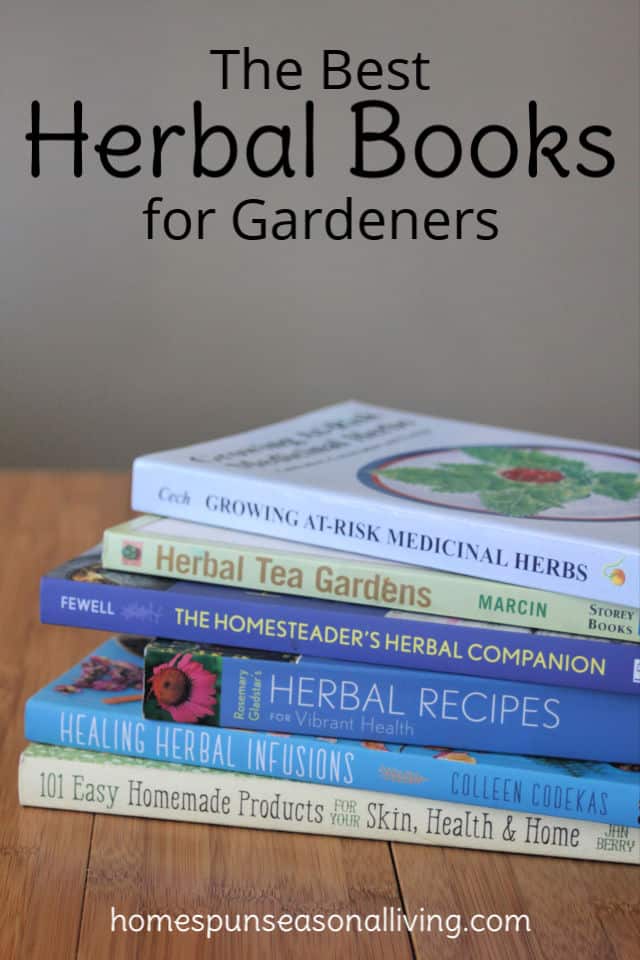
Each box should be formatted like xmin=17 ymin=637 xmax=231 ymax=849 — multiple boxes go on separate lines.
xmin=149 ymin=653 xmax=217 ymax=723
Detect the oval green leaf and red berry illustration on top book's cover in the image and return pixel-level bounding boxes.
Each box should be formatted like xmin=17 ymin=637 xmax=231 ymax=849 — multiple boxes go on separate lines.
xmin=359 ymin=446 xmax=640 ymax=521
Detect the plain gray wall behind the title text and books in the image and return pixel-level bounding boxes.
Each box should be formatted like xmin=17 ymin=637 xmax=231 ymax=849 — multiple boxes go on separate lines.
xmin=0 ymin=0 xmax=639 ymax=466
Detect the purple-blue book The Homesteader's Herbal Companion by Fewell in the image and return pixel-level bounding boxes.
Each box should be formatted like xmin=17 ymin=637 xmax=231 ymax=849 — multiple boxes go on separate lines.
xmin=40 ymin=547 xmax=640 ymax=694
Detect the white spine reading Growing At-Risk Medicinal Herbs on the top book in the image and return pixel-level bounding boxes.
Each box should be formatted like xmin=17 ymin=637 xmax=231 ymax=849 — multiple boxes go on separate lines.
xmin=132 ymin=457 xmax=640 ymax=607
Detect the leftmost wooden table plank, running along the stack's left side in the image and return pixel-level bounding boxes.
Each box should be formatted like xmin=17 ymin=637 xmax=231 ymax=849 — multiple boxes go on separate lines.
xmin=0 ymin=473 xmax=126 ymax=960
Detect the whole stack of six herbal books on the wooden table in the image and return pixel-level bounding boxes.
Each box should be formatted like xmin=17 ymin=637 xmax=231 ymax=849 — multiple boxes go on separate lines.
xmin=20 ymin=402 xmax=640 ymax=864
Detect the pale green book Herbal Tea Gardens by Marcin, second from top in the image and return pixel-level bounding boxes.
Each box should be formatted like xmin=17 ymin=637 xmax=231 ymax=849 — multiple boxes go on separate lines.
xmin=102 ymin=516 xmax=640 ymax=642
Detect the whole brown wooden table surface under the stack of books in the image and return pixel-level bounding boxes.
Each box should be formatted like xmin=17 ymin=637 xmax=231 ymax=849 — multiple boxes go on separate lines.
xmin=0 ymin=472 xmax=640 ymax=960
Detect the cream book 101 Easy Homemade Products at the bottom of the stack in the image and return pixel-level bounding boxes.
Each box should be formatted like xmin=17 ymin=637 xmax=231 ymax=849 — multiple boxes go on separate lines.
xmin=18 ymin=744 xmax=640 ymax=865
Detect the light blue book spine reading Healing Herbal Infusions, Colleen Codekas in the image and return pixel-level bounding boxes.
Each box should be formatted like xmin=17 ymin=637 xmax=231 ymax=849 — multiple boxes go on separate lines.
xmin=25 ymin=697 xmax=640 ymax=827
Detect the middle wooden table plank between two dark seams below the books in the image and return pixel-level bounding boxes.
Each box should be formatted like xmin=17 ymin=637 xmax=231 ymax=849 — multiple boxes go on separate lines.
xmin=79 ymin=817 xmax=412 ymax=960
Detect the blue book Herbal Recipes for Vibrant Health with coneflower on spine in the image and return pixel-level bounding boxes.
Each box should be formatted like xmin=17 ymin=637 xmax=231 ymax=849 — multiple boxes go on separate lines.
xmin=144 ymin=640 xmax=640 ymax=763
